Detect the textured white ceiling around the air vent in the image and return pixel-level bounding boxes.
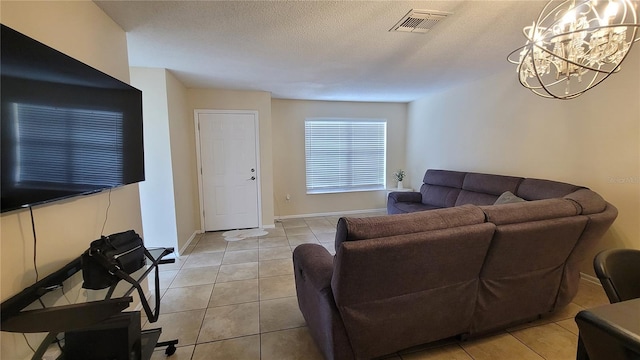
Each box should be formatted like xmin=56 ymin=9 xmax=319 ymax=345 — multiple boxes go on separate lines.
xmin=95 ymin=0 xmax=545 ymax=102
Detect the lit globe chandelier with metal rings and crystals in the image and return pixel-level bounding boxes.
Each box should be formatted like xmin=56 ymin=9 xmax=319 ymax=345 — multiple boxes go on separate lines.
xmin=508 ymin=0 xmax=640 ymax=100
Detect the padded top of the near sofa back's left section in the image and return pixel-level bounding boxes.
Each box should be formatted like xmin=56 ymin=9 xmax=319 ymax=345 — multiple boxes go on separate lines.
xmin=336 ymin=205 xmax=485 ymax=243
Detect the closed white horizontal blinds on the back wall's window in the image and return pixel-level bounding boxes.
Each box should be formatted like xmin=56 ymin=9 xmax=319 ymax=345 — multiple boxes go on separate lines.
xmin=304 ymin=119 xmax=387 ymax=194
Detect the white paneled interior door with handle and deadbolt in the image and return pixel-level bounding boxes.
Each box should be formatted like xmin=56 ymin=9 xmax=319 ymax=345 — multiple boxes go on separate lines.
xmin=196 ymin=111 xmax=260 ymax=231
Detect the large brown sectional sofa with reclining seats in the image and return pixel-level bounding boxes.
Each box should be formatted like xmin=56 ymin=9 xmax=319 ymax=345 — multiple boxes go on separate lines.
xmin=293 ymin=170 xmax=617 ymax=359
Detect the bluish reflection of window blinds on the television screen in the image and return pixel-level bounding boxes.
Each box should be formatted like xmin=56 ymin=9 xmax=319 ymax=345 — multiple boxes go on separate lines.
xmin=15 ymin=104 xmax=123 ymax=186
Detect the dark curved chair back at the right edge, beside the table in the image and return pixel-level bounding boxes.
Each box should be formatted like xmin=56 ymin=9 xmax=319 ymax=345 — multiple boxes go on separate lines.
xmin=593 ymin=249 xmax=640 ymax=304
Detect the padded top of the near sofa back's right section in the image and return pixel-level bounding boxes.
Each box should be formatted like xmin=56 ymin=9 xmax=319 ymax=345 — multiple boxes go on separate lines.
xmin=480 ymin=199 xmax=581 ymax=225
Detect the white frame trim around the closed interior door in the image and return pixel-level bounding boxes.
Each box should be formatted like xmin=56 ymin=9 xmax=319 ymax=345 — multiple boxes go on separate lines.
xmin=193 ymin=109 xmax=263 ymax=233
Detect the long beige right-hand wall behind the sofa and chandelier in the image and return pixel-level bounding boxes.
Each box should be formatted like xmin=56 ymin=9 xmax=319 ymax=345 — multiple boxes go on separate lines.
xmin=407 ymin=48 xmax=640 ymax=274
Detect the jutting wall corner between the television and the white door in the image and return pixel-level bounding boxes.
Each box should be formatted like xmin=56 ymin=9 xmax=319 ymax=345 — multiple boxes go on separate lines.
xmin=131 ymin=67 xmax=201 ymax=252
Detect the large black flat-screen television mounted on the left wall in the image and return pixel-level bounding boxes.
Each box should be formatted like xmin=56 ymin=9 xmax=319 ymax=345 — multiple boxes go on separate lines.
xmin=0 ymin=25 xmax=144 ymax=212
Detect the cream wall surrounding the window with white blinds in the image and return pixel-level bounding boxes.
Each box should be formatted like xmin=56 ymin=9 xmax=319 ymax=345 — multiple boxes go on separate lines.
xmin=272 ymin=99 xmax=404 ymax=216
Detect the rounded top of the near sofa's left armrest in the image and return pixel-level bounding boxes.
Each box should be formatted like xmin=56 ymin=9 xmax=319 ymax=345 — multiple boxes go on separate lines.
xmin=293 ymin=244 xmax=333 ymax=291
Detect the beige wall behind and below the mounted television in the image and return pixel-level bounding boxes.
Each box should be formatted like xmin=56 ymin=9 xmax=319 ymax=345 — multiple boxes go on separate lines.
xmin=0 ymin=1 xmax=142 ymax=359
